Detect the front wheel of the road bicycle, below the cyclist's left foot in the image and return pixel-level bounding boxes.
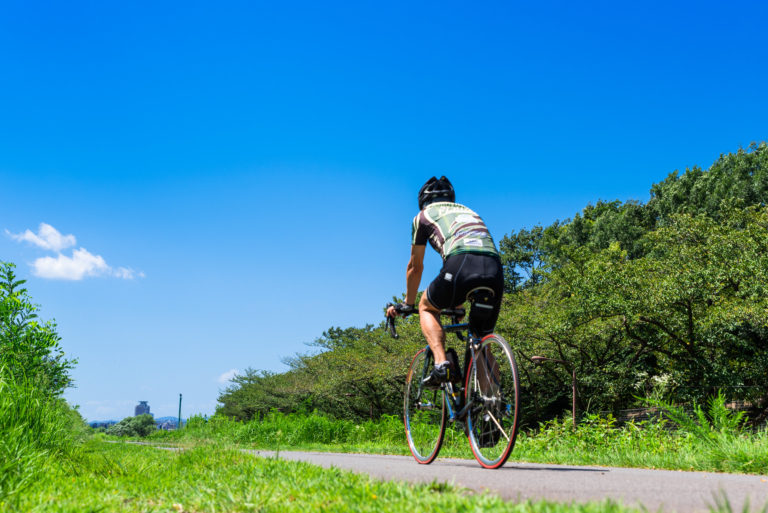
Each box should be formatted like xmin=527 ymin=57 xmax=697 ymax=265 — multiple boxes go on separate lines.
xmin=403 ymin=348 xmax=447 ymax=464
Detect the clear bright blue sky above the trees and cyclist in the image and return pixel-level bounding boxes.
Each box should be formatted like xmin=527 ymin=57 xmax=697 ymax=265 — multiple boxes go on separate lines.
xmin=0 ymin=2 xmax=768 ymax=420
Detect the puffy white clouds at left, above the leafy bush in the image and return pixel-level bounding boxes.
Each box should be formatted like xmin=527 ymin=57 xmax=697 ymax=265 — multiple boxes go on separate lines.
xmin=5 ymin=223 xmax=144 ymax=281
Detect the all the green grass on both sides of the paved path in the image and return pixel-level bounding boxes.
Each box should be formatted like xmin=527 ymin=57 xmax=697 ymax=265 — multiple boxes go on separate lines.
xmin=9 ymin=390 xmax=768 ymax=513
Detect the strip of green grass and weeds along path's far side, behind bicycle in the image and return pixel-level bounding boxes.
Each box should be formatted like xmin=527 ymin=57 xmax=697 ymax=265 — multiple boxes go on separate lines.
xmin=151 ymin=413 xmax=768 ymax=474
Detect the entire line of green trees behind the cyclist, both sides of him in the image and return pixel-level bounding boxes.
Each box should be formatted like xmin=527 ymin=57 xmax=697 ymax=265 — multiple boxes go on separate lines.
xmin=218 ymin=143 xmax=768 ymax=423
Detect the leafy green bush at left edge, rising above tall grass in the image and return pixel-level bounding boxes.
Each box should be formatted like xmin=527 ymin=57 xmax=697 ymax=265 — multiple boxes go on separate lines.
xmin=0 ymin=262 xmax=76 ymax=395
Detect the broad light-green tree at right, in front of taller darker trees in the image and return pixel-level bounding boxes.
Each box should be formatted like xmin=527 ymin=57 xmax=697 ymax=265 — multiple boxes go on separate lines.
xmin=536 ymin=207 xmax=768 ymax=406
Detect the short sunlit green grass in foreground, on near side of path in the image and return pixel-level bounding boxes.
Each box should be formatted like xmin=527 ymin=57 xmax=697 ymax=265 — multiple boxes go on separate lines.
xmin=13 ymin=440 xmax=648 ymax=513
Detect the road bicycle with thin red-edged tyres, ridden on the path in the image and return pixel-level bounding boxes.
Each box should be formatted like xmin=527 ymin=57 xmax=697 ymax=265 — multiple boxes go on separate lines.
xmin=387 ymin=296 xmax=520 ymax=469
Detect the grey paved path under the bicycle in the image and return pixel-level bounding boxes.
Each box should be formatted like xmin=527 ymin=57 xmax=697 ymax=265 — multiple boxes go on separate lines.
xmin=249 ymin=451 xmax=768 ymax=513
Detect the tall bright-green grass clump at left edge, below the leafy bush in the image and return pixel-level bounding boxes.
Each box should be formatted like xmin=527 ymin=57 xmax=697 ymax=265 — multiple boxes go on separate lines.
xmin=0 ymin=368 xmax=85 ymax=504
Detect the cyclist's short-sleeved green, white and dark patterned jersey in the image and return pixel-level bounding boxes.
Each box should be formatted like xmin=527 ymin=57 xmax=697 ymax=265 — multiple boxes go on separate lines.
xmin=411 ymin=201 xmax=499 ymax=260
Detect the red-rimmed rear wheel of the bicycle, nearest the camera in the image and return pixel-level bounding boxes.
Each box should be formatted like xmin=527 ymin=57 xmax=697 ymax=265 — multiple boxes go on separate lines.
xmin=466 ymin=334 xmax=520 ymax=468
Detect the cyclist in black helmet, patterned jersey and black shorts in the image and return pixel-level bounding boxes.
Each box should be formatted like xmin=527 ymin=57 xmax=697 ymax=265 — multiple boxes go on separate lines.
xmin=387 ymin=176 xmax=504 ymax=387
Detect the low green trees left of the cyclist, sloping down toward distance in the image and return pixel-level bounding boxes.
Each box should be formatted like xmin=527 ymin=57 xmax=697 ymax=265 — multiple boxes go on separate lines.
xmin=217 ymin=319 xmax=424 ymax=419
